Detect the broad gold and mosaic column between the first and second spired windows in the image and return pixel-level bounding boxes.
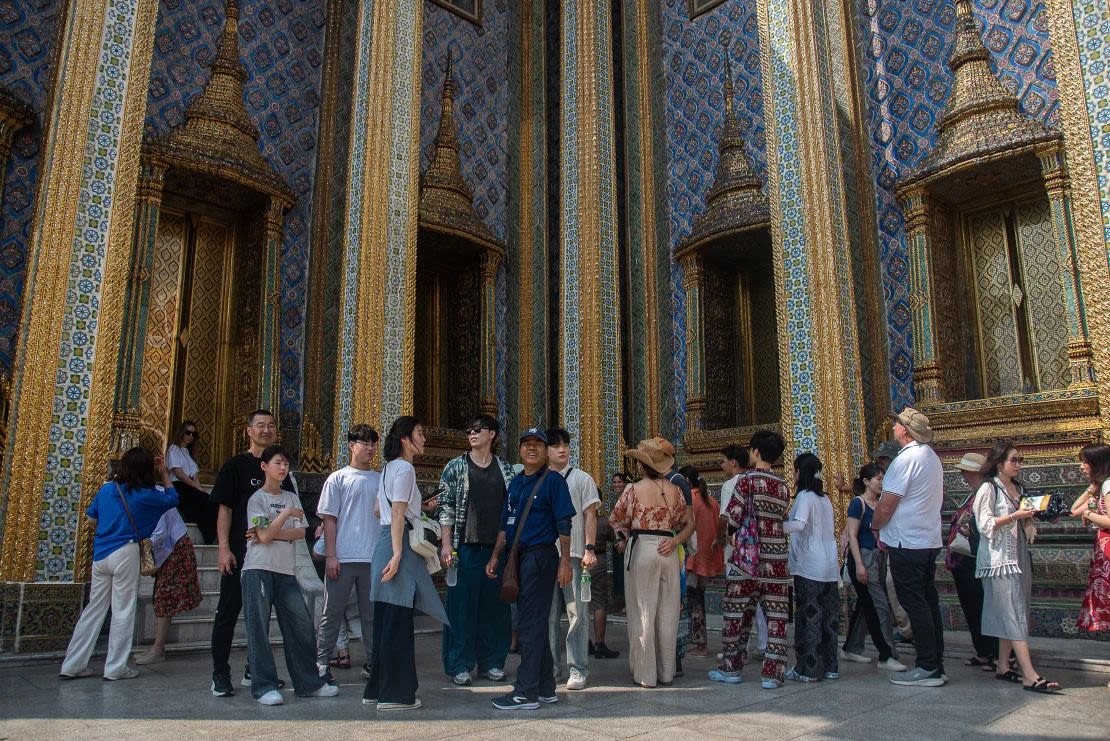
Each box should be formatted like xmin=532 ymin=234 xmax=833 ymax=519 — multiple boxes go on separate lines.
xmin=333 ymin=0 xmax=423 ymax=457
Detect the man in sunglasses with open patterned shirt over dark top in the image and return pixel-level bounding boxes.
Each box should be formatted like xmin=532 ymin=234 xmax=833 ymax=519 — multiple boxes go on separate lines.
xmin=437 ymin=415 xmax=513 ymax=687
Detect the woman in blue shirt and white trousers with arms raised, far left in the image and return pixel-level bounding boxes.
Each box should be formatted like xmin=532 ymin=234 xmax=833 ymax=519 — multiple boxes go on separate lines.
xmin=60 ymin=447 xmax=178 ymax=680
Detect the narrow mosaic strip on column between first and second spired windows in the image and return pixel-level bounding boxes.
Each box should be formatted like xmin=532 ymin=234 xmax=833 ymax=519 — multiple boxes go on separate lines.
xmin=332 ymin=0 xmax=377 ymax=466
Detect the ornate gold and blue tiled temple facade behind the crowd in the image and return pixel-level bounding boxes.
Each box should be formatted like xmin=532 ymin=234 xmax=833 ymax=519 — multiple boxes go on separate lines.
xmin=0 ymin=0 xmax=1110 ymax=653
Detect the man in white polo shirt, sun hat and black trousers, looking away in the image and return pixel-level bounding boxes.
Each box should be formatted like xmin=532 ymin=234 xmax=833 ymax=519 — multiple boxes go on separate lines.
xmin=871 ymin=407 xmax=946 ymax=687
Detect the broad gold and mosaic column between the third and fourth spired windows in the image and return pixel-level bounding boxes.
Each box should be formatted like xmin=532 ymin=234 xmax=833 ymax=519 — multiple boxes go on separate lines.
xmin=758 ymin=0 xmax=865 ymax=483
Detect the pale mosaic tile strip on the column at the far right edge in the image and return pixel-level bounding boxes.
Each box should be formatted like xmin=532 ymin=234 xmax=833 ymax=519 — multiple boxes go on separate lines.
xmin=1072 ymin=1 xmax=1110 ymax=251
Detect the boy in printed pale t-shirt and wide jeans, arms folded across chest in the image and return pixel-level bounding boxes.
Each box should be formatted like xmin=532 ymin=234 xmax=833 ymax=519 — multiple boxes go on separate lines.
xmin=241 ymin=445 xmax=339 ymax=706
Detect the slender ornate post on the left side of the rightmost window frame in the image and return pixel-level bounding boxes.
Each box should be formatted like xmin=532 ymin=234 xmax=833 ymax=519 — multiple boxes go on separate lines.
xmin=901 ymin=187 xmax=945 ymax=404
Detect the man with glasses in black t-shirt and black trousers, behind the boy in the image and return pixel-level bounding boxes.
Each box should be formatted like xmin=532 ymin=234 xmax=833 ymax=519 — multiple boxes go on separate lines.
xmin=209 ymin=409 xmax=296 ymax=698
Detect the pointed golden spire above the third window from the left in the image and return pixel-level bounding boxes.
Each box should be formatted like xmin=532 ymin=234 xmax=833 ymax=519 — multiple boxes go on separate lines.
xmin=676 ymin=41 xmax=770 ymax=256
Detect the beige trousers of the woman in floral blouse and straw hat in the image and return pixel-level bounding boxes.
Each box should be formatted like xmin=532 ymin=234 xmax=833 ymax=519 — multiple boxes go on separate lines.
xmin=625 ymin=535 xmax=682 ymax=687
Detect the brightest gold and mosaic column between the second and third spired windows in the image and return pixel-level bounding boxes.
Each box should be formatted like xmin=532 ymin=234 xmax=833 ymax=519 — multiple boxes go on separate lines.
xmin=563 ymin=0 xmax=623 ymax=481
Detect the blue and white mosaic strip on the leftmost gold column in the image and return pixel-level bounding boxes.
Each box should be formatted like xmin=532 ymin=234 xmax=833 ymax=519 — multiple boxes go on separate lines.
xmin=34 ymin=0 xmax=146 ymax=581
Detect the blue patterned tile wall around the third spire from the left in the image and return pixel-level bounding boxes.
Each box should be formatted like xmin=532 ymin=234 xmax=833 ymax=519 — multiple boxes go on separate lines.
xmin=662 ymin=0 xmax=767 ymax=438
